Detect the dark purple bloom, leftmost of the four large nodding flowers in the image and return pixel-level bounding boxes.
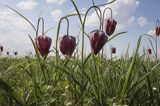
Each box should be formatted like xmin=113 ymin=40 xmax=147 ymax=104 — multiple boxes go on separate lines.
xmin=35 ymin=35 xmax=52 ymax=57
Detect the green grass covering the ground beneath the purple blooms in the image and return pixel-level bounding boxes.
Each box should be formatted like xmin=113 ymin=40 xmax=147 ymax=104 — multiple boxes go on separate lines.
xmin=0 ymin=48 xmax=160 ymax=106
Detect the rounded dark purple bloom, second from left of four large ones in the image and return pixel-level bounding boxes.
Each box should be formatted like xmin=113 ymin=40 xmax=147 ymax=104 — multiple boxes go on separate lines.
xmin=59 ymin=35 xmax=76 ymax=56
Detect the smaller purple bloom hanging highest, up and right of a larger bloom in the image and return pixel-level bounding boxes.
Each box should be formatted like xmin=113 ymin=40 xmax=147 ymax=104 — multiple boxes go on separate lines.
xmin=104 ymin=18 xmax=117 ymax=36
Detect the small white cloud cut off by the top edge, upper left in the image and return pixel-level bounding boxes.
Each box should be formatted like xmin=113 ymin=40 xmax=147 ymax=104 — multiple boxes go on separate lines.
xmin=17 ymin=0 xmax=38 ymax=10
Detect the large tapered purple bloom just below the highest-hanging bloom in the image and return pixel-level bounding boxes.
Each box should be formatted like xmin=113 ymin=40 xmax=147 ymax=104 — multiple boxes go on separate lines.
xmin=90 ymin=30 xmax=108 ymax=54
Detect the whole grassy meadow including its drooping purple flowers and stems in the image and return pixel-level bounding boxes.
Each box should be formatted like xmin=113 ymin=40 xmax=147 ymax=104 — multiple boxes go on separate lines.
xmin=0 ymin=0 xmax=160 ymax=106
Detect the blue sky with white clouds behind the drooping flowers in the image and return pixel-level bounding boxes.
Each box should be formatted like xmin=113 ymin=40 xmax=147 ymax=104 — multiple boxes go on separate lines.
xmin=0 ymin=0 xmax=160 ymax=55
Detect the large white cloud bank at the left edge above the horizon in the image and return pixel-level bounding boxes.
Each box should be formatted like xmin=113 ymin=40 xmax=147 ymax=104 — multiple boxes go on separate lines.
xmin=0 ymin=9 xmax=32 ymax=55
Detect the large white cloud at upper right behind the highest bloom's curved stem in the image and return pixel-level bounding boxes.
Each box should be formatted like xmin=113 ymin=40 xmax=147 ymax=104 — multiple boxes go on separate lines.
xmin=86 ymin=0 xmax=139 ymax=29
